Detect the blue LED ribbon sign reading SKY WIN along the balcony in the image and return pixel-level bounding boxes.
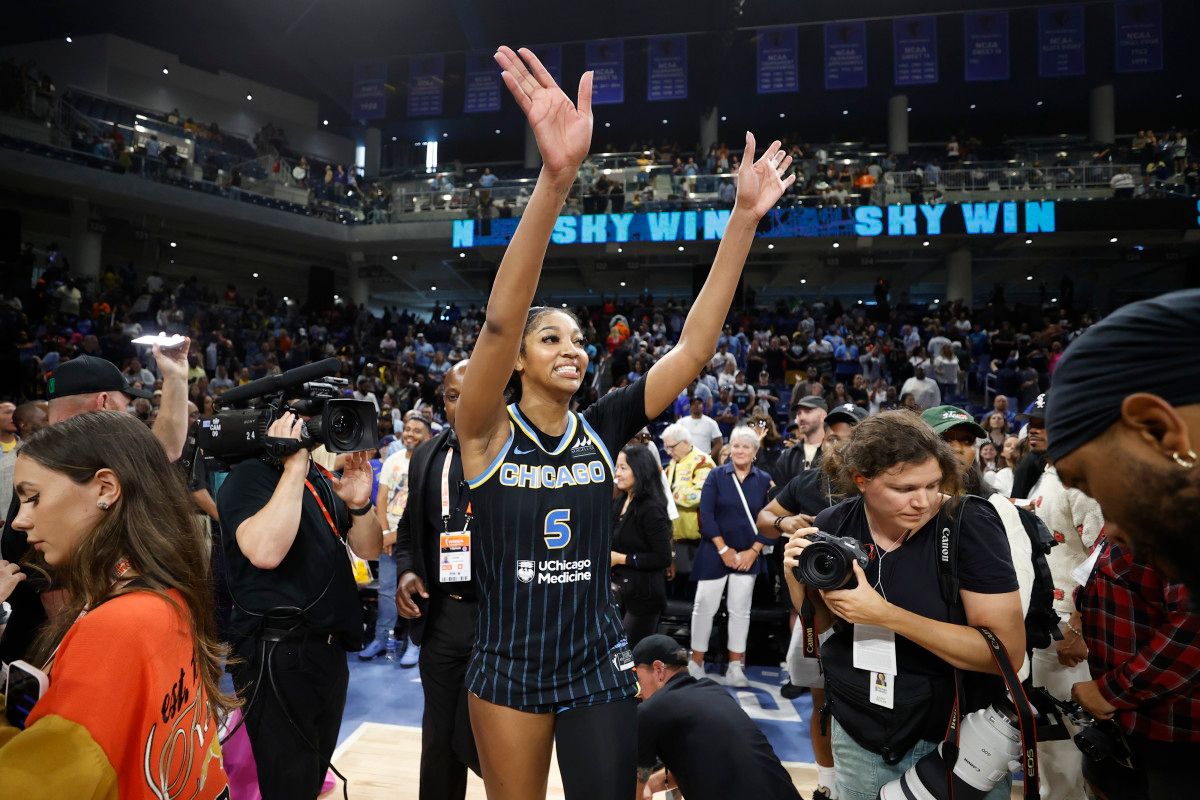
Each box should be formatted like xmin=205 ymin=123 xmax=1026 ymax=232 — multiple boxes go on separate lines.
xmin=451 ymin=200 xmax=1056 ymax=247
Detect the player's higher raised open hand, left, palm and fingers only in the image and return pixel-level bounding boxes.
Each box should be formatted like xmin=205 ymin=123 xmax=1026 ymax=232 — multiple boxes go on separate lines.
xmin=494 ymin=46 xmax=592 ymax=181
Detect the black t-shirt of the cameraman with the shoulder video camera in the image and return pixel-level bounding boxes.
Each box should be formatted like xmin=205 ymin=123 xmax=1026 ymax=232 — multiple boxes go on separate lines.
xmin=217 ymin=458 xmax=362 ymax=650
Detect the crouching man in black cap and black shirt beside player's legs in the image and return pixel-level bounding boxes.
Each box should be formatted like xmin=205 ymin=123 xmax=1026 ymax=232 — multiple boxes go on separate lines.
xmin=634 ymin=633 xmax=800 ymax=800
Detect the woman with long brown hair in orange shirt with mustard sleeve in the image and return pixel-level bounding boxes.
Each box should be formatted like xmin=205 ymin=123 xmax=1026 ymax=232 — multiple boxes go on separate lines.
xmin=0 ymin=411 xmax=235 ymax=799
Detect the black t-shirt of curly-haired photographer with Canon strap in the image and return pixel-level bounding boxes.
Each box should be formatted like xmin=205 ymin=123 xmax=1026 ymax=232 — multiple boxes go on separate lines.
xmin=814 ymin=498 xmax=1016 ymax=676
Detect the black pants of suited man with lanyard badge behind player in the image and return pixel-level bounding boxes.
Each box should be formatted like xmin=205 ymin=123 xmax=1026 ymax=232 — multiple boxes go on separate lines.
xmin=419 ymin=590 xmax=480 ymax=800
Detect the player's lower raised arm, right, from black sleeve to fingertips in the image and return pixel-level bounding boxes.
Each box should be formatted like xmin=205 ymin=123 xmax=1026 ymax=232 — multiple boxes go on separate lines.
xmin=646 ymin=131 xmax=796 ymax=420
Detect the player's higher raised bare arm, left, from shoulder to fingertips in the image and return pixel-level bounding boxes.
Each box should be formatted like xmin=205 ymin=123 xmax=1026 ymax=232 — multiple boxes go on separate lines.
xmin=455 ymin=47 xmax=592 ymax=460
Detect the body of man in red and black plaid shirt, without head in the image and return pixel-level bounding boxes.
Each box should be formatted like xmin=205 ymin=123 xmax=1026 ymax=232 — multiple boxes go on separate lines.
xmin=1072 ymin=532 xmax=1200 ymax=800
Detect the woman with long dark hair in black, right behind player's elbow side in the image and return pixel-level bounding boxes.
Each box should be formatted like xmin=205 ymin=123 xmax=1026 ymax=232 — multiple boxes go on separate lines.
xmin=610 ymin=444 xmax=671 ymax=649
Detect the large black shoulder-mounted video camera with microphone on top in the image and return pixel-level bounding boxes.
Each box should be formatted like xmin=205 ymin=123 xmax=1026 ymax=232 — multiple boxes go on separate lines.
xmin=185 ymin=359 xmax=378 ymax=467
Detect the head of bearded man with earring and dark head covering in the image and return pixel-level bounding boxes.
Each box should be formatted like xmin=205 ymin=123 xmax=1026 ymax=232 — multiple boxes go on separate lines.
xmin=1046 ymin=289 xmax=1200 ymax=601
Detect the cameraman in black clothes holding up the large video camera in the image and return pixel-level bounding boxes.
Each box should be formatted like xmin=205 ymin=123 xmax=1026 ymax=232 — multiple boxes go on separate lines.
xmin=217 ymin=413 xmax=383 ymax=800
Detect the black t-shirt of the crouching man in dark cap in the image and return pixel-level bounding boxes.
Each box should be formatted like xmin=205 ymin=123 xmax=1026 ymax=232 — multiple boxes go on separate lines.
xmin=637 ymin=672 xmax=800 ymax=800
